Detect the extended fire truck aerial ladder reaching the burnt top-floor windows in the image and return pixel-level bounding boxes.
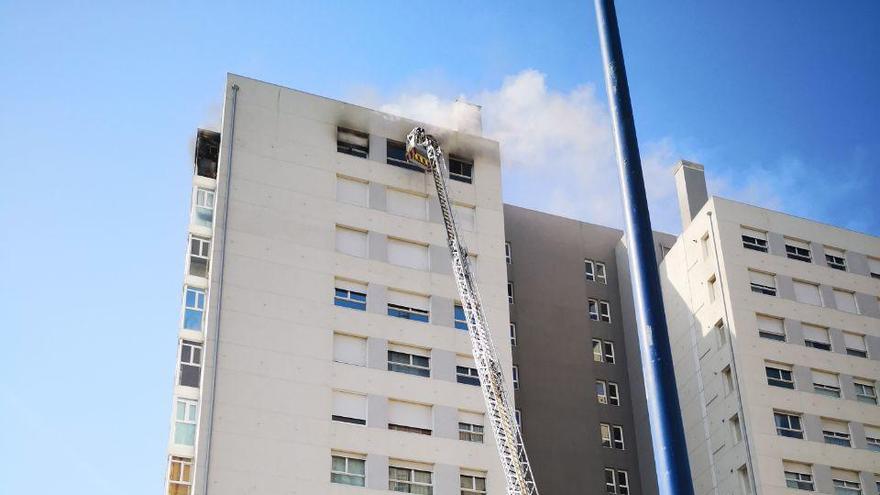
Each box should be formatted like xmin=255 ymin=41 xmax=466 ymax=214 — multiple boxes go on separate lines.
xmin=406 ymin=127 xmax=538 ymax=495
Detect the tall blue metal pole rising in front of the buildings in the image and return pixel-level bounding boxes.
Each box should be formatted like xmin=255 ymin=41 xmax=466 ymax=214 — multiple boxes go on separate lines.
xmin=595 ymin=0 xmax=694 ymax=495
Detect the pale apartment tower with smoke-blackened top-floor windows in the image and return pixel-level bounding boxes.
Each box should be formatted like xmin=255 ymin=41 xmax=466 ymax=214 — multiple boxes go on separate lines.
xmin=166 ymin=75 xmax=513 ymax=495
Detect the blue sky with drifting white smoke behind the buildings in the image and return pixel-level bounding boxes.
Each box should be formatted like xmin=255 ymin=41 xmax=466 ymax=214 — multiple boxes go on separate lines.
xmin=0 ymin=0 xmax=880 ymax=495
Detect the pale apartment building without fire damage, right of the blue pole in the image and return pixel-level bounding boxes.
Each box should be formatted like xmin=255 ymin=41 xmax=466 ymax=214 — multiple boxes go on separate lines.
xmin=661 ymin=162 xmax=880 ymax=495
